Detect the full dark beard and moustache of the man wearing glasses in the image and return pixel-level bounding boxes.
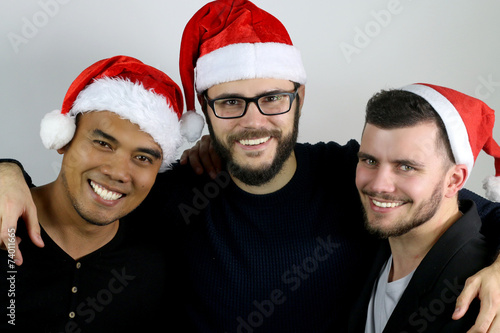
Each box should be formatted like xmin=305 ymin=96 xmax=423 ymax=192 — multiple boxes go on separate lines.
xmin=206 ymin=104 xmax=299 ymax=186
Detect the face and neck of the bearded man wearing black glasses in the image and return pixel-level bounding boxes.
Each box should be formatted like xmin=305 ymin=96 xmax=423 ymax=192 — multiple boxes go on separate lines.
xmin=202 ymin=79 xmax=304 ymax=189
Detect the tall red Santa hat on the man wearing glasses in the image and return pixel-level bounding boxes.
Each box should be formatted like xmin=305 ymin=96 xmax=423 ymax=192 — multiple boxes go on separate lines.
xmin=179 ymin=0 xmax=306 ymax=110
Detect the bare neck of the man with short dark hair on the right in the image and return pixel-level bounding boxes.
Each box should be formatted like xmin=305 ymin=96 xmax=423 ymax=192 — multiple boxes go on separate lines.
xmin=389 ymin=203 xmax=463 ymax=282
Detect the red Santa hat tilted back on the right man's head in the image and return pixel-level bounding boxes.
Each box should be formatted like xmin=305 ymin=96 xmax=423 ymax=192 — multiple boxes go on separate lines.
xmin=402 ymin=83 xmax=500 ymax=202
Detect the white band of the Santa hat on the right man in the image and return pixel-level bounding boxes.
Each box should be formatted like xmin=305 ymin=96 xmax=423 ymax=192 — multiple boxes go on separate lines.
xmin=401 ymin=84 xmax=474 ymax=182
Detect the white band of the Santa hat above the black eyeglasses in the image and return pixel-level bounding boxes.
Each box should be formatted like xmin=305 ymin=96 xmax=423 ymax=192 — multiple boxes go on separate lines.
xmin=195 ymin=43 xmax=306 ymax=93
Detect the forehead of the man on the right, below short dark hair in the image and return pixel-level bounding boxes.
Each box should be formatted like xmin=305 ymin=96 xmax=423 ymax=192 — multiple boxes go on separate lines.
xmin=360 ymin=123 xmax=440 ymax=162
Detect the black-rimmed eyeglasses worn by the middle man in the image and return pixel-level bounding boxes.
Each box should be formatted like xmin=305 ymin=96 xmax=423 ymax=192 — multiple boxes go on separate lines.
xmin=203 ymin=89 xmax=298 ymax=119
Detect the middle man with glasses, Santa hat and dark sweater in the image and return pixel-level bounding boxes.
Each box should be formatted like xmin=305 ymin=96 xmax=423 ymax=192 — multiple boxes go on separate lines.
xmin=0 ymin=0 xmax=497 ymax=332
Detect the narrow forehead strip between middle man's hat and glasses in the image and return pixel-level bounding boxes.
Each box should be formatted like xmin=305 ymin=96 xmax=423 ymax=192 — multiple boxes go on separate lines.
xmin=207 ymin=79 xmax=294 ymax=97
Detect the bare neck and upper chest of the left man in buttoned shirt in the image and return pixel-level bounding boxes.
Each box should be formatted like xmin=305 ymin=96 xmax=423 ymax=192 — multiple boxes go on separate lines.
xmin=31 ymin=181 xmax=119 ymax=260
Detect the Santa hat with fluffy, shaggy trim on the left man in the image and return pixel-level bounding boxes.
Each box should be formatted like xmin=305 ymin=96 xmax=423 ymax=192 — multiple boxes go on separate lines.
xmin=40 ymin=56 xmax=199 ymax=172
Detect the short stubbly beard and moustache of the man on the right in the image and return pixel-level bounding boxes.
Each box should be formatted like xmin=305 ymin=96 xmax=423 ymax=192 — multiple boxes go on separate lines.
xmin=362 ymin=182 xmax=443 ymax=239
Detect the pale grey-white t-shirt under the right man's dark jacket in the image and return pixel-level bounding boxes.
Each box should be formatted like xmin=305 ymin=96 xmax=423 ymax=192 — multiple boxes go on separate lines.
xmin=365 ymin=255 xmax=415 ymax=333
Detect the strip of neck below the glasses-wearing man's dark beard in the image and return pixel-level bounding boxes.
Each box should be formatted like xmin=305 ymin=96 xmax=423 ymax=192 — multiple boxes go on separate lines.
xmin=231 ymin=152 xmax=297 ymax=194
